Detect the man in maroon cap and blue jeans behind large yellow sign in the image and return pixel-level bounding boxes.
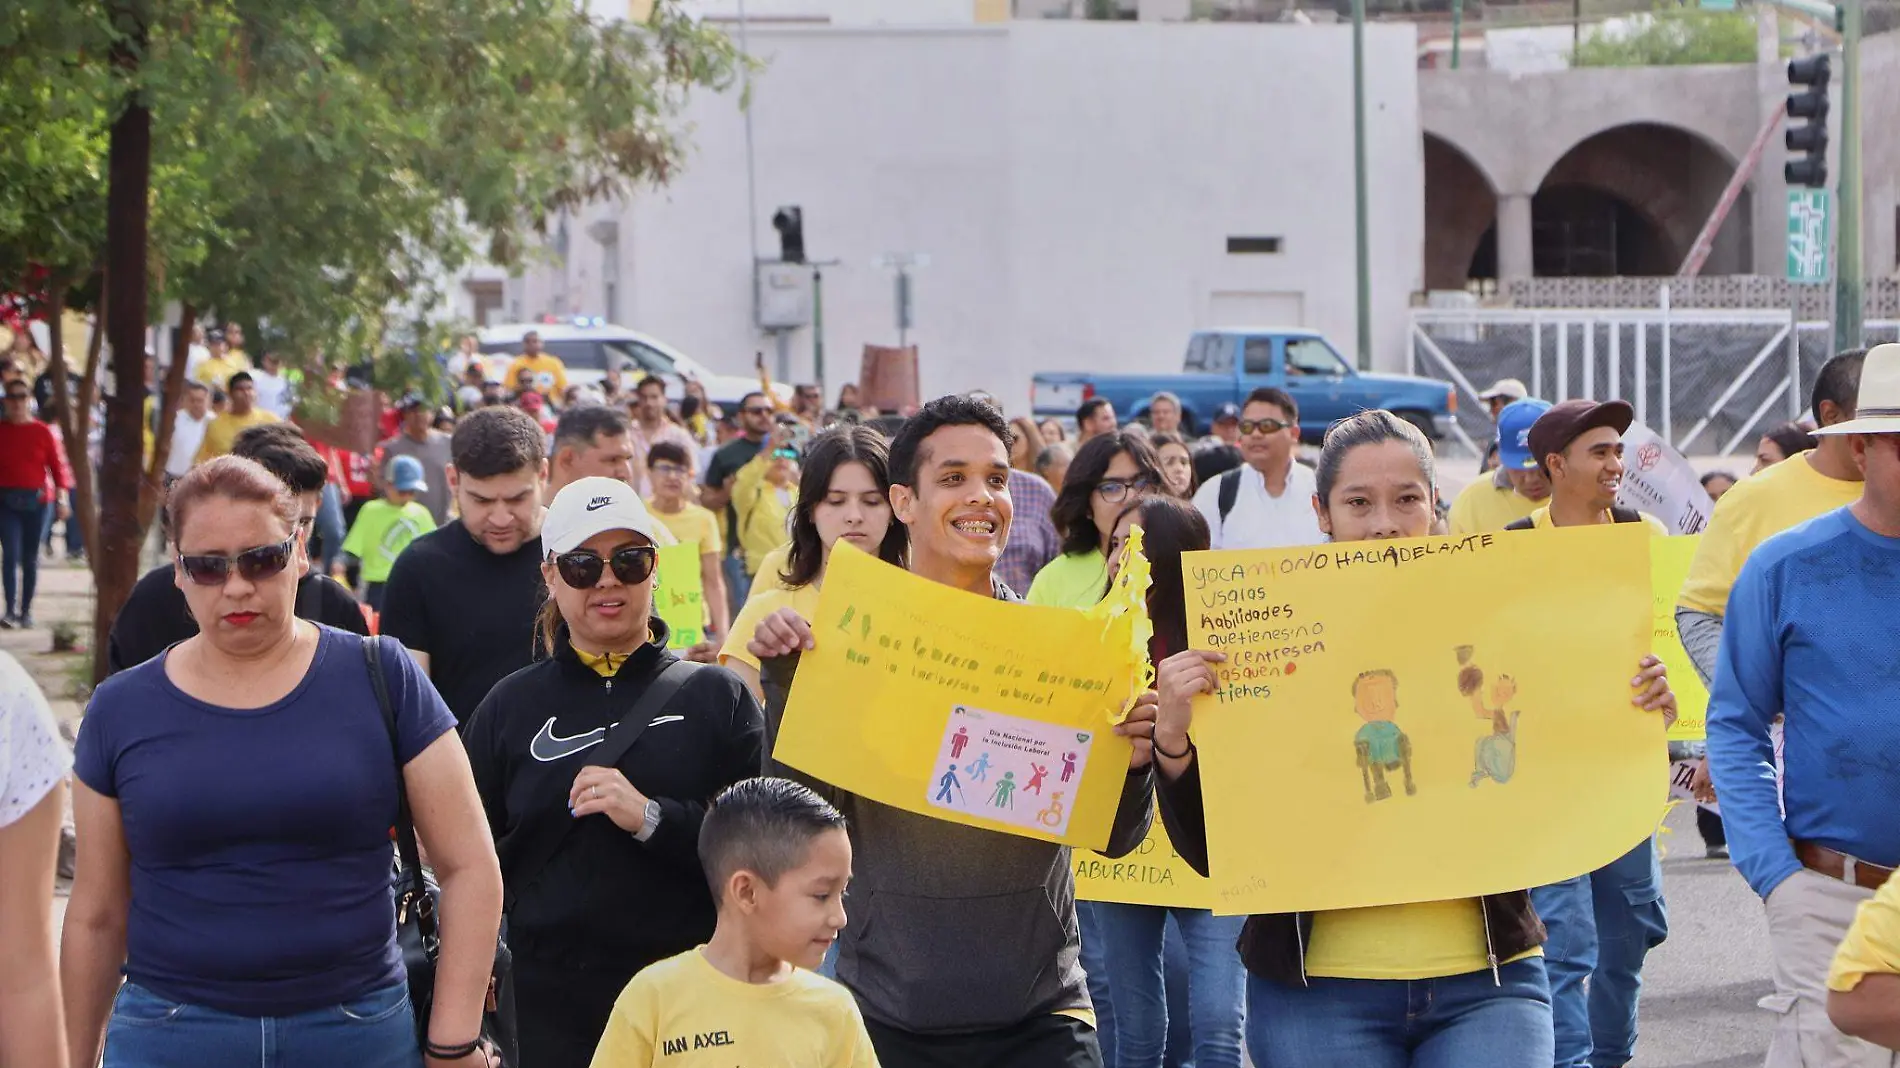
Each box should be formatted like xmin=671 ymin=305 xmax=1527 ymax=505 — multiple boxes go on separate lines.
xmin=1505 ymin=401 xmax=1668 ymax=1068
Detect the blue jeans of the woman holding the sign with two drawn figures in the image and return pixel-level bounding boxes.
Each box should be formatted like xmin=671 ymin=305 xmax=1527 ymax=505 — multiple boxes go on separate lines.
xmin=1246 ymin=956 xmax=1552 ymax=1068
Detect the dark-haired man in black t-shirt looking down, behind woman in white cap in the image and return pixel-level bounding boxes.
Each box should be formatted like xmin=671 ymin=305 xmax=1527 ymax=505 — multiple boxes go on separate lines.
xmin=382 ymin=407 xmax=547 ymax=726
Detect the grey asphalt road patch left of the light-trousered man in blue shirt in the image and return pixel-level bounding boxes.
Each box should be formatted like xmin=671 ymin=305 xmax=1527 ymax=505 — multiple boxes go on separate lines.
xmin=1632 ymin=806 xmax=1775 ymax=1068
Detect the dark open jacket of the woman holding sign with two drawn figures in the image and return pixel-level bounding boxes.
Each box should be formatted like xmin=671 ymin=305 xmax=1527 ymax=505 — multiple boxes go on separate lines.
xmin=1155 ymin=760 xmax=1545 ymax=986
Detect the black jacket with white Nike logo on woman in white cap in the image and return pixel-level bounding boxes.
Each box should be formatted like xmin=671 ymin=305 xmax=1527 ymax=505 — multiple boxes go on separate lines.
xmin=464 ymin=618 xmax=766 ymax=975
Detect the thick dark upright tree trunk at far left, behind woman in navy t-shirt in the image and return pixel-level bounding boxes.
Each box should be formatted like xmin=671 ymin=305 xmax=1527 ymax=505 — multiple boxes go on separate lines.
xmin=93 ymin=4 xmax=152 ymax=680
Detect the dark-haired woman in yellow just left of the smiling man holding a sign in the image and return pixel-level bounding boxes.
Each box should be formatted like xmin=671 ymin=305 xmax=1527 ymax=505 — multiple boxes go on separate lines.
xmin=718 ymin=426 xmax=908 ymax=699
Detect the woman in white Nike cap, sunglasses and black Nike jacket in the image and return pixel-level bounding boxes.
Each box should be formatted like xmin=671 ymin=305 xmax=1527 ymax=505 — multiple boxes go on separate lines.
xmin=464 ymin=477 xmax=766 ymax=1068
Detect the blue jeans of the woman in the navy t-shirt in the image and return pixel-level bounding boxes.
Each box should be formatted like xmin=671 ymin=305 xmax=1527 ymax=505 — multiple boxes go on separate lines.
xmin=103 ymin=982 xmax=422 ymax=1068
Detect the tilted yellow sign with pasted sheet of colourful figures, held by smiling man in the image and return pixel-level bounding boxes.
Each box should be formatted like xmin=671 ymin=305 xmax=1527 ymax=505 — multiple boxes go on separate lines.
xmin=773 ymin=549 xmax=1146 ymax=849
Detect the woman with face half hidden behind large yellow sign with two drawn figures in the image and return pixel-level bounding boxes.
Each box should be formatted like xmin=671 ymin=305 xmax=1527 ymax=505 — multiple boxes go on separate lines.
xmin=1153 ymin=410 xmax=1676 ymax=1068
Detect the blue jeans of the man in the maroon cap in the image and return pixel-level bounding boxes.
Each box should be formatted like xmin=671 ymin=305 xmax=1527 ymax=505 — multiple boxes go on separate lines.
xmin=1531 ymin=838 xmax=1668 ymax=1068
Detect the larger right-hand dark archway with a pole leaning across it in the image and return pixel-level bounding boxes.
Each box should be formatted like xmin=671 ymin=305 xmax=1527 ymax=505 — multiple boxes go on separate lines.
xmin=1531 ymin=124 xmax=1752 ymax=277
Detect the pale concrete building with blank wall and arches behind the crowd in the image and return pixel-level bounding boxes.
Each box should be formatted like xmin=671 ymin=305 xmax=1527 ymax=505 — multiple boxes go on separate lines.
xmin=483 ymin=10 xmax=1900 ymax=407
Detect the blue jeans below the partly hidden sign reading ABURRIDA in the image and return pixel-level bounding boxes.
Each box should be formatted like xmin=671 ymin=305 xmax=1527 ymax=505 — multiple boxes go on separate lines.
xmin=1094 ymin=903 xmax=1246 ymax=1068
